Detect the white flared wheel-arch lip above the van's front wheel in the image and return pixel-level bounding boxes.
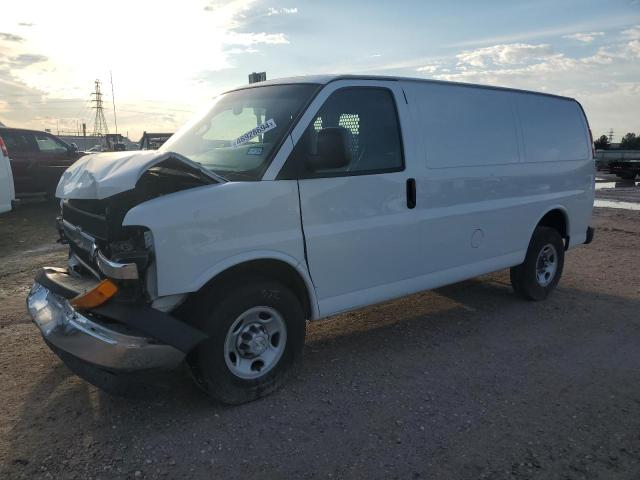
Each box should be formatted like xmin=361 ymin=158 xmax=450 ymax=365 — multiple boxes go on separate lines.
xmin=185 ymin=252 xmax=320 ymax=320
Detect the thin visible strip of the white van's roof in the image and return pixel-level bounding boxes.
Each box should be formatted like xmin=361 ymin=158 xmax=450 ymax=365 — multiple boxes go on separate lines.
xmin=232 ymin=74 xmax=576 ymax=101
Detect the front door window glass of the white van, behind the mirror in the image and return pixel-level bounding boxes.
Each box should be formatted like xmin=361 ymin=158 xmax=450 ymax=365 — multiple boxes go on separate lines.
xmin=283 ymin=87 xmax=404 ymax=178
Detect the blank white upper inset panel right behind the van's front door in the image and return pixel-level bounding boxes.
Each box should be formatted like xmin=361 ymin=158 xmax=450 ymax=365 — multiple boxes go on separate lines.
xmin=413 ymin=84 xmax=519 ymax=168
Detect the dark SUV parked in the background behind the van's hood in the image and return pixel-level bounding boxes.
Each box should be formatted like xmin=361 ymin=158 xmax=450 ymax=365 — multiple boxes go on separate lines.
xmin=0 ymin=127 xmax=85 ymax=197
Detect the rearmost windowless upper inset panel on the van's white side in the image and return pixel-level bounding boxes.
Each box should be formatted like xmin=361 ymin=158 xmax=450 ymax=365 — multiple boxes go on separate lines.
xmin=517 ymin=95 xmax=590 ymax=162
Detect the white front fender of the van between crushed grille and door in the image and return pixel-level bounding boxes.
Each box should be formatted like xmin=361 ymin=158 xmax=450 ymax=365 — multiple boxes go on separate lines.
xmin=123 ymin=180 xmax=317 ymax=316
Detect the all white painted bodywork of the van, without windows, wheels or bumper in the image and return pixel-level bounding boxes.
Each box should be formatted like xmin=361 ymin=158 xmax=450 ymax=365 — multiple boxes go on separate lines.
xmin=52 ymin=78 xmax=595 ymax=319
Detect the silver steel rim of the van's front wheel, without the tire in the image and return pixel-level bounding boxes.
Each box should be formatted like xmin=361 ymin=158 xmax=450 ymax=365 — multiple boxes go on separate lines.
xmin=224 ymin=307 xmax=287 ymax=379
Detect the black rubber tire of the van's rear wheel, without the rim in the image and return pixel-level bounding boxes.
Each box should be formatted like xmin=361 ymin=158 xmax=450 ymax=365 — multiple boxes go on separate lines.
xmin=510 ymin=227 xmax=564 ymax=301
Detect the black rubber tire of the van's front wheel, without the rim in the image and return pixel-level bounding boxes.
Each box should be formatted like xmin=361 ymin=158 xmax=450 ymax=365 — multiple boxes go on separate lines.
xmin=189 ymin=278 xmax=306 ymax=405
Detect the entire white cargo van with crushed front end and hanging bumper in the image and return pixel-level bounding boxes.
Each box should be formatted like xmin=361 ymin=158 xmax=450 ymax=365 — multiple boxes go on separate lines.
xmin=28 ymin=76 xmax=595 ymax=403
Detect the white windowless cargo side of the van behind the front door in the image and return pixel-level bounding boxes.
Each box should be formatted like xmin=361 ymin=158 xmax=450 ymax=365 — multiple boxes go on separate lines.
xmin=403 ymin=81 xmax=594 ymax=282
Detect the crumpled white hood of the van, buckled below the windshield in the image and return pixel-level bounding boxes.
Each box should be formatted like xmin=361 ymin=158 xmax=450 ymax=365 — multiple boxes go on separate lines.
xmin=56 ymin=150 xmax=220 ymax=200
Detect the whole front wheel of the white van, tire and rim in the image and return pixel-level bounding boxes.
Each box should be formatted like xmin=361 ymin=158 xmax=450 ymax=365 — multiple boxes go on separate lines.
xmin=190 ymin=279 xmax=306 ymax=404
